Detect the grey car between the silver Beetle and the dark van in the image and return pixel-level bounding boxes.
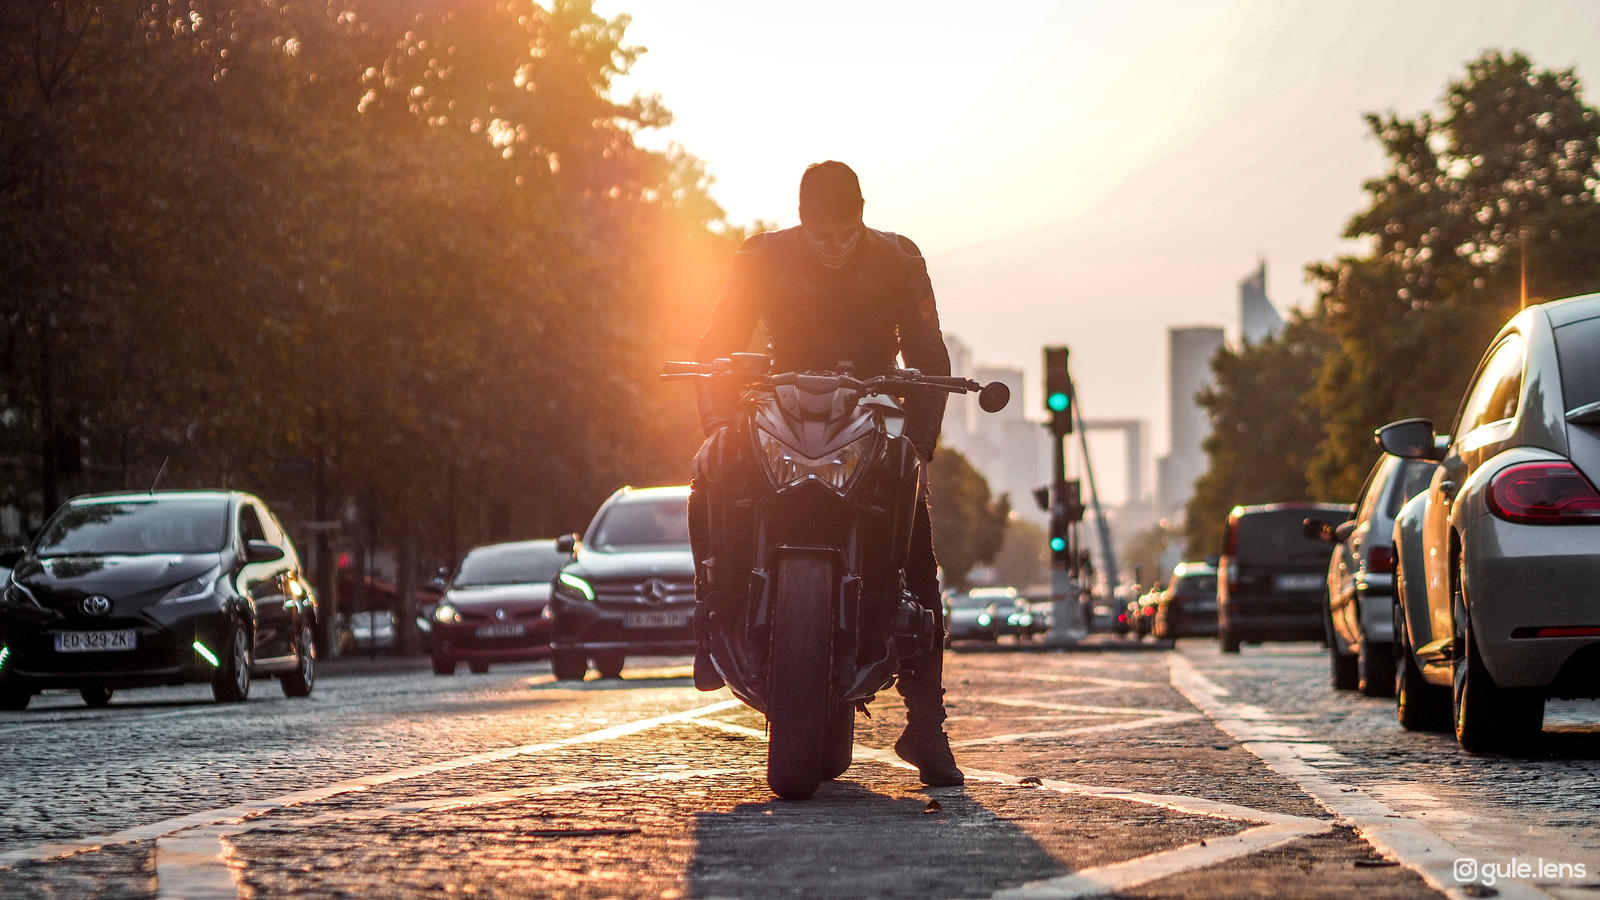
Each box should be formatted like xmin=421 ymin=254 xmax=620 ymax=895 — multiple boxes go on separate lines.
xmin=1306 ymin=453 xmax=1434 ymax=697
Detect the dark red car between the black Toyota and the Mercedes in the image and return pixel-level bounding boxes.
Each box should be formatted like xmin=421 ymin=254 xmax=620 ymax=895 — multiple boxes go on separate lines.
xmin=429 ymin=540 xmax=571 ymax=674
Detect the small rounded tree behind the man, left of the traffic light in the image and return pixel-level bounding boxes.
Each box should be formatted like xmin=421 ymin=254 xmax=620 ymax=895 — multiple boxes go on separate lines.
xmin=928 ymin=447 xmax=1011 ymax=586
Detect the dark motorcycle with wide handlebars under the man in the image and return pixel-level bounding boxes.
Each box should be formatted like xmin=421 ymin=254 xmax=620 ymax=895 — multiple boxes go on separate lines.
xmin=662 ymin=354 xmax=1010 ymax=799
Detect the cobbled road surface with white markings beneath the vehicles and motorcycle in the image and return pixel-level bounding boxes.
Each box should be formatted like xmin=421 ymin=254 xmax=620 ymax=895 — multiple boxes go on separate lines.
xmin=0 ymin=642 xmax=1600 ymax=898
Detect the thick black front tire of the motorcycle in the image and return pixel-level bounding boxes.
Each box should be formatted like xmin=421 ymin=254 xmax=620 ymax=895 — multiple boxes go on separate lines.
xmin=766 ymin=554 xmax=834 ymax=801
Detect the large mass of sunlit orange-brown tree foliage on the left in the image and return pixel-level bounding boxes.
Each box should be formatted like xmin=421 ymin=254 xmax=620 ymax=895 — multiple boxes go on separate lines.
xmin=0 ymin=0 xmax=739 ymax=556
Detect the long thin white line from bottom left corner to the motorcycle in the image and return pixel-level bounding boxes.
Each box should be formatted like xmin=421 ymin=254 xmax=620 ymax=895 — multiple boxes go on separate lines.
xmin=0 ymin=700 xmax=741 ymax=870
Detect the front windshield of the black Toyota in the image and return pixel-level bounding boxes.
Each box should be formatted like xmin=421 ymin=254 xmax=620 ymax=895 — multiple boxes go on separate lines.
xmin=35 ymin=496 xmax=227 ymax=556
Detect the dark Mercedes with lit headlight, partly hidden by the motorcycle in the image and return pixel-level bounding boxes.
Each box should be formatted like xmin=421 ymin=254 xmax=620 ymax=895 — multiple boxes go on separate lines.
xmin=549 ymin=485 xmax=694 ymax=681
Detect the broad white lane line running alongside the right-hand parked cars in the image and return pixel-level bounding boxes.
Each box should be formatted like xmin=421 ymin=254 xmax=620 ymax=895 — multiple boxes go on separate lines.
xmin=1170 ymin=652 xmax=1550 ymax=900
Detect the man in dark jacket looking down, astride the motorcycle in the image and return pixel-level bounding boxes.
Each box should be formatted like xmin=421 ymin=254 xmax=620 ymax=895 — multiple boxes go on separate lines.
xmin=694 ymin=160 xmax=963 ymax=785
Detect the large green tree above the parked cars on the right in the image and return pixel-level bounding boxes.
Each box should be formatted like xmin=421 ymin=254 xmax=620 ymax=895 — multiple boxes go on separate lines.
xmin=1187 ymin=51 xmax=1600 ymax=552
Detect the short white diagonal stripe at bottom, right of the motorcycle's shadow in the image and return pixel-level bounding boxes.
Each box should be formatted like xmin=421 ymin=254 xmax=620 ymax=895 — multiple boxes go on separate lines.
xmin=990 ymin=820 xmax=1333 ymax=900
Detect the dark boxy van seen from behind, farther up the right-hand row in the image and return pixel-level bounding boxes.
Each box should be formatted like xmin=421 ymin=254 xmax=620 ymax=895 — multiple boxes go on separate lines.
xmin=1216 ymin=503 xmax=1352 ymax=653
